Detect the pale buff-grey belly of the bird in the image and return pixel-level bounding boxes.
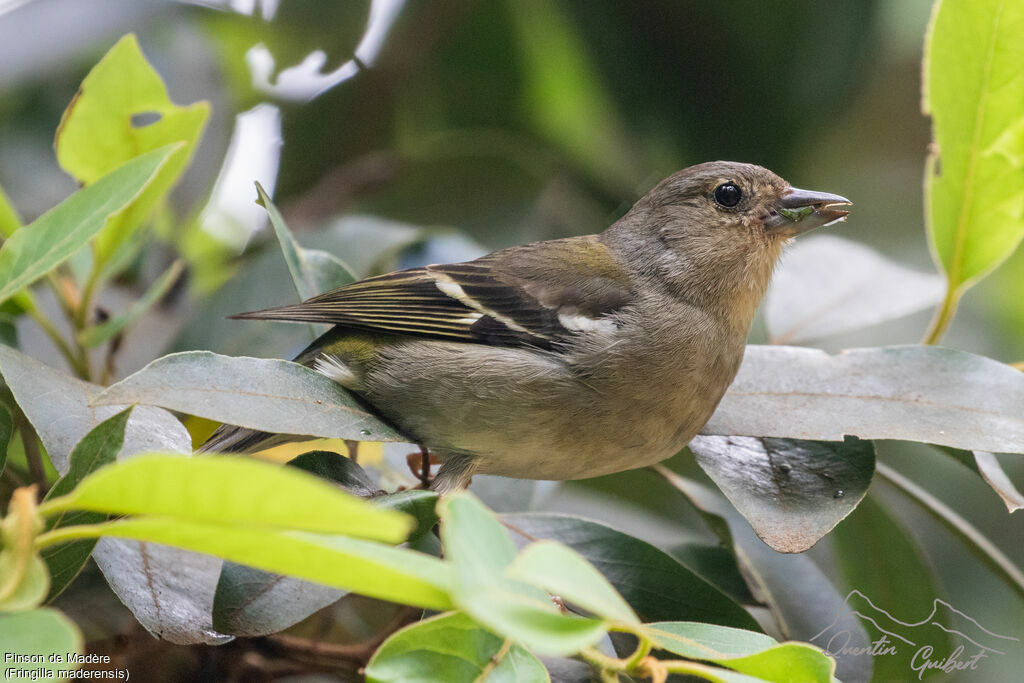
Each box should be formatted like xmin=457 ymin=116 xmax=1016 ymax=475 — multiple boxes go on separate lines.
xmin=367 ymin=335 xmax=731 ymax=479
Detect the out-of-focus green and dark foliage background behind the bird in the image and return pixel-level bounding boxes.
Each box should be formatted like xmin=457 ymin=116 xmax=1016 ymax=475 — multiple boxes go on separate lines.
xmin=0 ymin=0 xmax=1024 ymax=680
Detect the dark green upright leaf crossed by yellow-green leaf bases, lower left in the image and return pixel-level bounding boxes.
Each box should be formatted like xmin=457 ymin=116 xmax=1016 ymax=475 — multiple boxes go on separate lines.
xmin=42 ymin=408 xmax=132 ymax=602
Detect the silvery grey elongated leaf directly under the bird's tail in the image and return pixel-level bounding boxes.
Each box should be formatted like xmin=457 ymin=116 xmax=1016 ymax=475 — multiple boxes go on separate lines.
xmin=93 ymin=351 xmax=409 ymax=441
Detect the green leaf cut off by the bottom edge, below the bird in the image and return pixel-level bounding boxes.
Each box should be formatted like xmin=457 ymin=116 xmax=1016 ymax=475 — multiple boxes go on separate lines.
xmin=366 ymin=612 xmax=550 ymax=683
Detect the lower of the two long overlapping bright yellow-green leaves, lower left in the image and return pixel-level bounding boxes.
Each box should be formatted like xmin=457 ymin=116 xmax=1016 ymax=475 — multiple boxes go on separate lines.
xmin=40 ymin=520 xmax=454 ymax=609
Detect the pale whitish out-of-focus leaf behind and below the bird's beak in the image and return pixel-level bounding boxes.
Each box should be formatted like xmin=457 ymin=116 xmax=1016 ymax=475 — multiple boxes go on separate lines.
xmin=765 ymin=234 xmax=943 ymax=344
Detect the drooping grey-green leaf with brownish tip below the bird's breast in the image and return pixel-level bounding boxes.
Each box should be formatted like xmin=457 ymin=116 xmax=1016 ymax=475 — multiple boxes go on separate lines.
xmin=690 ymin=436 xmax=874 ymax=553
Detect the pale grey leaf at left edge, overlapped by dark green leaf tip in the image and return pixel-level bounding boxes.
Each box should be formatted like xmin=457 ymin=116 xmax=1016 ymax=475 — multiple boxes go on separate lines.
xmin=0 ymin=345 xmax=191 ymax=474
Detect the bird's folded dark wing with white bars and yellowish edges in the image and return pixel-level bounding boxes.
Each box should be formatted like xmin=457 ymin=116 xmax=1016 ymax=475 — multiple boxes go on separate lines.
xmin=232 ymin=237 xmax=633 ymax=348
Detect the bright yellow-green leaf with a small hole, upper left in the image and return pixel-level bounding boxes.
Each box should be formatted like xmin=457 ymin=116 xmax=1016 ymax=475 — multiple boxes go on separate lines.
xmin=55 ymin=34 xmax=210 ymax=264
